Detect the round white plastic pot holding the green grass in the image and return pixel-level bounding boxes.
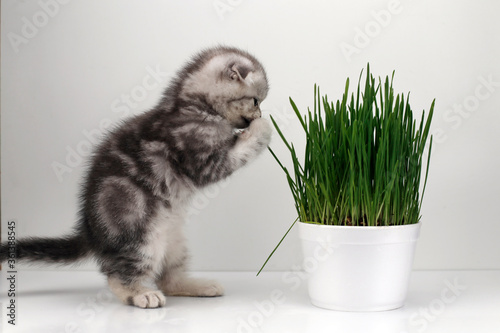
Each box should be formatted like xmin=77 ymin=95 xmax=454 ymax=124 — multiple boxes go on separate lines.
xmin=299 ymin=222 xmax=421 ymax=311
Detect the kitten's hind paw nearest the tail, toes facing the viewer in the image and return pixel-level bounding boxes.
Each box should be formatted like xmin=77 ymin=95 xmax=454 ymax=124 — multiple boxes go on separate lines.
xmin=108 ymin=276 xmax=166 ymax=308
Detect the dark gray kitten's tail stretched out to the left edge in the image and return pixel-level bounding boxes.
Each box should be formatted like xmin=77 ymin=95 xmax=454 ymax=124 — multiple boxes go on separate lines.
xmin=0 ymin=234 xmax=90 ymax=264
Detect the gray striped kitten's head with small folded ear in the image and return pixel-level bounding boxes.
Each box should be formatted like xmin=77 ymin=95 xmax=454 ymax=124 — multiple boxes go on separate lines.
xmin=179 ymin=47 xmax=269 ymax=128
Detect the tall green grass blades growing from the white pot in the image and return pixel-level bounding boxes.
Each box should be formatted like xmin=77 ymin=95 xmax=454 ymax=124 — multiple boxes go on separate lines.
xmin=259 ymin=65 xmax=434 ymax=273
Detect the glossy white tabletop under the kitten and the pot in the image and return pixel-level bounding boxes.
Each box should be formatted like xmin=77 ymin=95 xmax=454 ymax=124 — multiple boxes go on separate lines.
xmin=0 ymin=266 xmax=500 ymax=333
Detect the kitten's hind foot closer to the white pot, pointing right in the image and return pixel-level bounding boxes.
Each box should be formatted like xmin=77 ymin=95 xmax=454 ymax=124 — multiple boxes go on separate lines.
xmin=156 ymin=265 xmax=224 ymax=297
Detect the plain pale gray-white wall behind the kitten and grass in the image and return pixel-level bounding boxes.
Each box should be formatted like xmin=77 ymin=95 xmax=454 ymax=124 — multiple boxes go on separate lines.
xmin=1 ymin=0 xmax=500 ymax=271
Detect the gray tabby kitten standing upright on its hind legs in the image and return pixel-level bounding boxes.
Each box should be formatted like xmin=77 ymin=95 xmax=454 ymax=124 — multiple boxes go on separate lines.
xmin=0 ymin=47 xmax=271 ymax=308
